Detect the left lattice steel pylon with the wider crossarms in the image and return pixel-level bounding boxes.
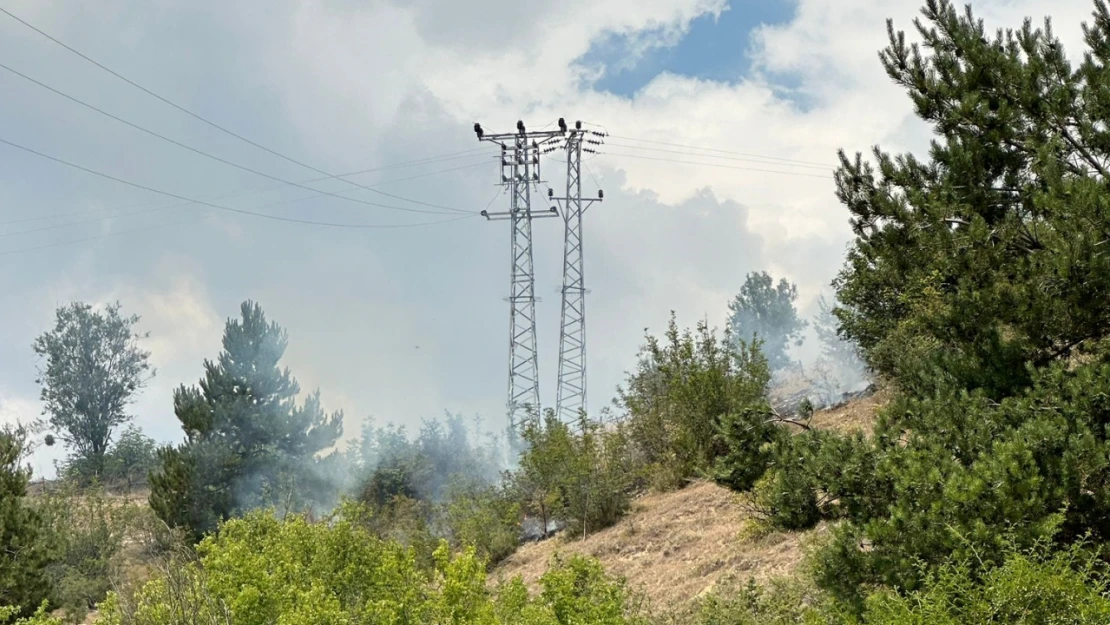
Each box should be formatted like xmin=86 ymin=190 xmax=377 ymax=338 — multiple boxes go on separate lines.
xmin=474 ymin=121 xmax=564 ymax=423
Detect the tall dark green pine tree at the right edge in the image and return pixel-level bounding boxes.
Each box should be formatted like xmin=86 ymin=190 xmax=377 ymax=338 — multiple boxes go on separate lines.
xmin=836 ymin=0 xmax=1110 ymax=400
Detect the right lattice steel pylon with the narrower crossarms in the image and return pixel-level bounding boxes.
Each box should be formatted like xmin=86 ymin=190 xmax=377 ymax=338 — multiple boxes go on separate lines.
xmin=555 ymin=122 xmax=602 ymax=422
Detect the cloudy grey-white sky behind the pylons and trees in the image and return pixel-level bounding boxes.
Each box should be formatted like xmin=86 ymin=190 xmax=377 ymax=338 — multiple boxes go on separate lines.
xmin=0 ymin=0 xmax=1092 ymax=475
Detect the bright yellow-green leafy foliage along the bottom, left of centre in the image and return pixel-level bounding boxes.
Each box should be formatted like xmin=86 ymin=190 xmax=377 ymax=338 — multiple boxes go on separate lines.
xmin=101 ymin=504 xmax=644 ymax=625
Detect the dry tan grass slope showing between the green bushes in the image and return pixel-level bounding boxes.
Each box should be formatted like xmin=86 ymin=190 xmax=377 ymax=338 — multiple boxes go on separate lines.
xmin=491 ymin=392 xmax=887 ymax=607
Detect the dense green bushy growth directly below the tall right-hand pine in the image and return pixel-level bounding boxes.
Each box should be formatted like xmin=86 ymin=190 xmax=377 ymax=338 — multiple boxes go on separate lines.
xmin=803 ymin=364 xmax=1110 ymax=603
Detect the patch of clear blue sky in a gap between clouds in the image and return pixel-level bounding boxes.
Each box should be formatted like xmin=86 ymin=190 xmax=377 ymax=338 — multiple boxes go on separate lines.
xmin=577 ymin=0 xmax=796 ymax=97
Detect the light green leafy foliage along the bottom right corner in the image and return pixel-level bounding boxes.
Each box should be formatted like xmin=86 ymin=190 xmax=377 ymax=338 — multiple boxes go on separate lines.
xmin=663 ymin=542 xmax=1110 ymax=625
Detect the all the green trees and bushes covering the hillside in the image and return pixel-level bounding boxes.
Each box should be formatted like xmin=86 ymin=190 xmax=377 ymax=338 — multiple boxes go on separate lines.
xmin=10 ymin=0 xmax=1110 ymax=625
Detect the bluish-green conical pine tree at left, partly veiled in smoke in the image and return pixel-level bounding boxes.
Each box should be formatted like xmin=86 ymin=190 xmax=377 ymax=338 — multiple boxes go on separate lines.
xmin=150 ymin=301 xmax=343 ymax=536
